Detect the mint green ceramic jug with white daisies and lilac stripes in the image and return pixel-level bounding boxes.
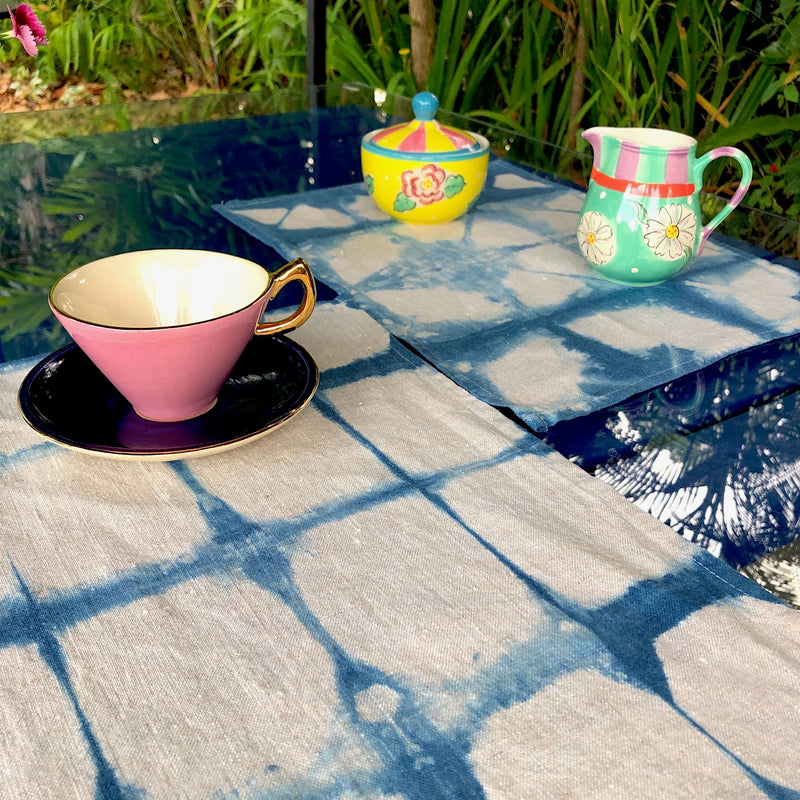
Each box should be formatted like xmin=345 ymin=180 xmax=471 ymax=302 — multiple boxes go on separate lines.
xmin=578 ymin=128 xmax=753 ymax=286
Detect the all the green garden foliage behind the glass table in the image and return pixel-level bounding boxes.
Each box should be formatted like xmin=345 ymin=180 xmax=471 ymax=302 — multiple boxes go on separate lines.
xmin=4 ymin=0 xmax=800 ymax=223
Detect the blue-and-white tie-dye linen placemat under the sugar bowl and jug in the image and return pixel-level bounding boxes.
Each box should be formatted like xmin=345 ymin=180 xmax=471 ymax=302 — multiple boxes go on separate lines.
xmin=215 ymin=161 xmax=800 ymax=430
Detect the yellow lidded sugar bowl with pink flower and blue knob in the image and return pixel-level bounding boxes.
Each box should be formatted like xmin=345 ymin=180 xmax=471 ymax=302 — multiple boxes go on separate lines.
xmin=361 ymin=92 xmax=489 ymax=225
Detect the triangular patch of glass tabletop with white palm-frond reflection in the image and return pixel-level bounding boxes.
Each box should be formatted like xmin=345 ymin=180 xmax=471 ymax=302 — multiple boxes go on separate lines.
xmin=543 ymin=335 xmax=800 ymax=604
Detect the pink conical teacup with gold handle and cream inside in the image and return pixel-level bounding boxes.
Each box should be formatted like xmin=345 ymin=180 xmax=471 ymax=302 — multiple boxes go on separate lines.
xmin=50 ymin=250 xmax=316 ymax=422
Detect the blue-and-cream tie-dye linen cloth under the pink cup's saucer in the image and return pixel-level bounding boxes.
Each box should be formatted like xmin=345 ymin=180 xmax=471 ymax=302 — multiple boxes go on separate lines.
xmin=0 ymin=303 xmax=800 ymax=800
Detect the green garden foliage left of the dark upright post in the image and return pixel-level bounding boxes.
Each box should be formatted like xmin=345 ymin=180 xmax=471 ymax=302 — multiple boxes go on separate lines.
xmin=4 ymin=0 xmax=306 ymax=97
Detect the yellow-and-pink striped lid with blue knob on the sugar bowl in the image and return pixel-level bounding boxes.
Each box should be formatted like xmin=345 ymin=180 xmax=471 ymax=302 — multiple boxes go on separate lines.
xmin=362 ymin=92 xmax=488 ymax=158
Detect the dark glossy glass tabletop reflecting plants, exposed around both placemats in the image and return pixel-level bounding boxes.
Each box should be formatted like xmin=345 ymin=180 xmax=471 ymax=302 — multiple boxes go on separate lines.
xmin=0 ymin=86 xmax=800 ymax=602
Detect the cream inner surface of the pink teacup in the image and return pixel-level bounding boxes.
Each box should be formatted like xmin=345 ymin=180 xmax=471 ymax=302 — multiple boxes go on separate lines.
xmin=50 ymin=250 xmax=270 ymax=328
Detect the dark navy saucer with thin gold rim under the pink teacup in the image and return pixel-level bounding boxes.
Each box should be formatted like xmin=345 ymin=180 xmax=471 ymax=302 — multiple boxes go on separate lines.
xmin=19 ymin=336 xmax=319 ymax=461
